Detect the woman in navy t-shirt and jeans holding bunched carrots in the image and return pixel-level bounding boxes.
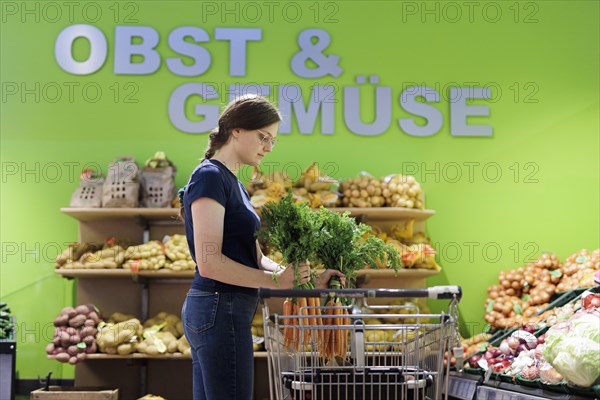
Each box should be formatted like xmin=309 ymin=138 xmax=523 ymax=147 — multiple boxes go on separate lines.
xmin=181 ymin=96 xmax=343 ymax=400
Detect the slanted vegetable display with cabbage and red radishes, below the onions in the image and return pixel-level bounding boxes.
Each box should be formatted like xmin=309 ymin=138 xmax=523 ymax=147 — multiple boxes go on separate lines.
xmin=463 ymin=287 xmax=600 ymax=394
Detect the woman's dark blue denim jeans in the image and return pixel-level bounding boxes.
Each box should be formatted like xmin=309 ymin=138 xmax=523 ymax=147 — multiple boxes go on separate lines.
xmin=181 ymin=289 xmax=258 ymax=400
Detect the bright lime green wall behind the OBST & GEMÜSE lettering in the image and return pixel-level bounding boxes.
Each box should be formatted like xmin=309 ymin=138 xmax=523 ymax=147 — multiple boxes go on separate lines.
xmin=0 ymin=1 xmax=600 ymax=378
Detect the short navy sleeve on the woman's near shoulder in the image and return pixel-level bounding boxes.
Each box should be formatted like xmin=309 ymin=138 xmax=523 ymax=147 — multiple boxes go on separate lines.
xmin=184 ymin=165 xmax=228 ymax=207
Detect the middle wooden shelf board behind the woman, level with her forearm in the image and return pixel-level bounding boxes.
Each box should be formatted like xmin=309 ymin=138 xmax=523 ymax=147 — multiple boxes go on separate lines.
xmin=56 ymin=268 xmax=439 ymax=279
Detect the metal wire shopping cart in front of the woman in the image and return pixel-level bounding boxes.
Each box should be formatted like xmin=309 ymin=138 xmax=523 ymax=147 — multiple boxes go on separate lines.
xmin=259 ymin=286 xmax=462 ymax=400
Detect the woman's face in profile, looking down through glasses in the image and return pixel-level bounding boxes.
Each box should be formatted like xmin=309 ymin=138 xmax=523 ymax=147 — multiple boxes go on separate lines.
xmin=236 ymin=122 xmax=279 ymax=166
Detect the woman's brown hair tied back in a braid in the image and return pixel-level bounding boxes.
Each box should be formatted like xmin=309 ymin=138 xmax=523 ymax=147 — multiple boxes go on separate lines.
xmin=179 ymin=94 xmax=281 ymax=220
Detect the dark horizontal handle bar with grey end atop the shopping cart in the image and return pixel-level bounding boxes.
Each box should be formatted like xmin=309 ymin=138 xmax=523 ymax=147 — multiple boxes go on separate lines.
xmin=258 ymin=286 xmax=462 ymax=300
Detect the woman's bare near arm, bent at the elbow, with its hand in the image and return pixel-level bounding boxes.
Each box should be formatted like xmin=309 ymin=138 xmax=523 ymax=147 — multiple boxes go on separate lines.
xmin=191 ymin=197 xmax=310 ymax=289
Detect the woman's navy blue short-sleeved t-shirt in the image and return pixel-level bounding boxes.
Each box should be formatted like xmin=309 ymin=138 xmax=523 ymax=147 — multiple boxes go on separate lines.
xmin=183 ymin=160 xmax=260 ymax=295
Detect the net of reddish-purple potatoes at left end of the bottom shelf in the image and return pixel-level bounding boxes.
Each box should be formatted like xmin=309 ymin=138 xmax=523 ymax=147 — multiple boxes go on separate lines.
xmin=46 ymin=304 xmax=101 ymax=364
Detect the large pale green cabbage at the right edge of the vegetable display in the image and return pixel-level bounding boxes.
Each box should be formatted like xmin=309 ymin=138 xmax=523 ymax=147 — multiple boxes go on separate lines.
xmin=542 ymin=313 xmax=600 ymax=387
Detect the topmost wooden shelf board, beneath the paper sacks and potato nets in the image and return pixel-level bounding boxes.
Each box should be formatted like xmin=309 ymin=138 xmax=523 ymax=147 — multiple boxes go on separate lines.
xmin=60 ymin=207 xmax=435 ymax=222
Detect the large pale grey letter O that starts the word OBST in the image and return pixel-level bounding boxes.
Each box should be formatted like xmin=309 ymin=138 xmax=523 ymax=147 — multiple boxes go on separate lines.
xmin=54 ymin=24 xmax=108 ymax=75
